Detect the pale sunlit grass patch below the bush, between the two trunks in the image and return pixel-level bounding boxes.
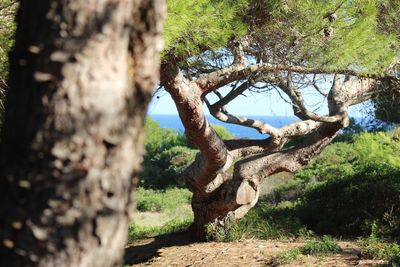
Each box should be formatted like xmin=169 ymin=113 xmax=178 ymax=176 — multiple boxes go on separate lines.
xmin=134 ymin=188 xmax=192 ymax=212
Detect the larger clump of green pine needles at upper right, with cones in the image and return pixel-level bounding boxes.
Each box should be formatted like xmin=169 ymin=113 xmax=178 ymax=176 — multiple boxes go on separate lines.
xmin=254 ymin=0 xmax=400 ymax=74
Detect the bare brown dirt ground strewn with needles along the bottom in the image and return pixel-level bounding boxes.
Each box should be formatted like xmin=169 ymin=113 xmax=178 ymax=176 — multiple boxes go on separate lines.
xmin=125 ymin=233 xmax=385 ymax=267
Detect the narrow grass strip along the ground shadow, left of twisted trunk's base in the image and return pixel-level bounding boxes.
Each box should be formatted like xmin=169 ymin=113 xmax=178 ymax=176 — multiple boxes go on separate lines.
xmin=128 ymin=217 xmax=193 ymax=242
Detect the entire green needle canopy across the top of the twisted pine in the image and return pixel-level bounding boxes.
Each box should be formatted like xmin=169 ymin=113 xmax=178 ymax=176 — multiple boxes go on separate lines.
xmin=164 ymin=0 xmax=400 ymax=74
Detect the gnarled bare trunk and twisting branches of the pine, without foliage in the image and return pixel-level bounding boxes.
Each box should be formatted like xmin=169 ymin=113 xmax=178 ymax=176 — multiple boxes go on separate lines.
xmin=160 ymin=57 xmax=376 ymax=240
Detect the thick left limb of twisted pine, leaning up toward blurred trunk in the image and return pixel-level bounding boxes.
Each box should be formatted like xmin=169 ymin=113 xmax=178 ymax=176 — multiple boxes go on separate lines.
xmin=161 ymin=61 xmax=230 ymax=198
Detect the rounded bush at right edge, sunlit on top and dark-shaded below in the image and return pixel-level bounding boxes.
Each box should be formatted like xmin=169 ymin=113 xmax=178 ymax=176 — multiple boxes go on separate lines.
xmin=296 ymin=131 xmax=400 ymax=238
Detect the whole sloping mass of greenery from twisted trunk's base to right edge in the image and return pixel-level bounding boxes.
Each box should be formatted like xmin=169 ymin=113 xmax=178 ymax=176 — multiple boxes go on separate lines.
xmin=220 ymin=130 xmax=400 ymax=242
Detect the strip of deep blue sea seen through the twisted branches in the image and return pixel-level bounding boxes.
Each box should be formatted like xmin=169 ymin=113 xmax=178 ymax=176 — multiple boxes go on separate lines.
xmin=150 ymin=114 xmax=298 ymax=139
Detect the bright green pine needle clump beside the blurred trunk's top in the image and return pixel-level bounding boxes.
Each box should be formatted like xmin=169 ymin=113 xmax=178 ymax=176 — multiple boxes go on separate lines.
xmin=164 ymin=0 xmax=248 ymax=57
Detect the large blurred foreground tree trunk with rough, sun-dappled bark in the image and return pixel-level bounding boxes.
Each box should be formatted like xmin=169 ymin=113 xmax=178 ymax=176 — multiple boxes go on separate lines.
xmin=0 ymin=0 xmax=164 ymax=266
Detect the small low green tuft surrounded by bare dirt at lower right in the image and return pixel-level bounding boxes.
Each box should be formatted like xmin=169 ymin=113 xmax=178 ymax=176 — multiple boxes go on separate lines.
xmin=300 ymin=235 xmax=342 ymax=255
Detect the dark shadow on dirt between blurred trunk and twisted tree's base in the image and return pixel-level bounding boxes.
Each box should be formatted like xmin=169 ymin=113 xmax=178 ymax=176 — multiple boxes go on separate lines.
xmin=124 ymin=231 xmax=195 ymax=265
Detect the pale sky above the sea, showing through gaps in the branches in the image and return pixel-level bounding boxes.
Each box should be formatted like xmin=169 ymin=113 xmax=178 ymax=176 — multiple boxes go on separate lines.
xmin=148 ymin=85 xmax=364 ymax=117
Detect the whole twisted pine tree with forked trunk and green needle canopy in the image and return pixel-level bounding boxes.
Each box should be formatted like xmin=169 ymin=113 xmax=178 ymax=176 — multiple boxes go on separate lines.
xmin=160 ymin=0 xmax=399 ymax=239
